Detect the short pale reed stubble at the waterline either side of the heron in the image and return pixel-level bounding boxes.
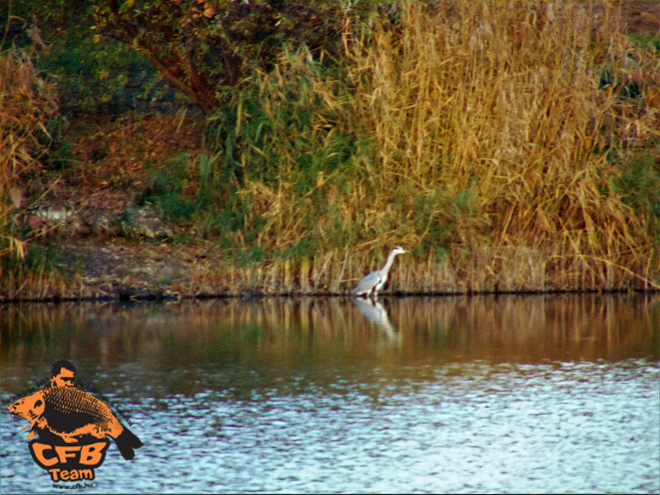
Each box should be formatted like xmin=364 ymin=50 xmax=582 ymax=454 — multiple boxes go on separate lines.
xmin=196 ymin=250 xmax=660 ymax=295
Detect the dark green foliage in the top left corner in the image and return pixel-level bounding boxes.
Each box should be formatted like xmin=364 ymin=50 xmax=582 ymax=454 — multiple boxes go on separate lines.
xmin=0 ymin=0 xmax=175 ymax=117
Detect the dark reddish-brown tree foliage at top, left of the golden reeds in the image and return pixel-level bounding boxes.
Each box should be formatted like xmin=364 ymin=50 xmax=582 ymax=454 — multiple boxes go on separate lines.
xmin=95 ymin=0 xmax=371 ymax=113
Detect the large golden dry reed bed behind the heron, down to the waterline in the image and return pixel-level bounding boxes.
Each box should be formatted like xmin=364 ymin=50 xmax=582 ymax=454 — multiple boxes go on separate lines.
xmin=224 ymin=0 xmax=660 ymax=293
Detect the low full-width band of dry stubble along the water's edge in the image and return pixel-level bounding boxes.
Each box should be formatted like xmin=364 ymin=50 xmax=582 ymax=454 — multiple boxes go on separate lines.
xmin=0 ymin=246 xmax=660 ymax=301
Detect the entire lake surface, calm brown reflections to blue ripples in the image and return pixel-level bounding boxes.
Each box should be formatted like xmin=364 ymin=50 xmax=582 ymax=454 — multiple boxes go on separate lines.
xmin=0 ymin=294 xmax=660 ymax=493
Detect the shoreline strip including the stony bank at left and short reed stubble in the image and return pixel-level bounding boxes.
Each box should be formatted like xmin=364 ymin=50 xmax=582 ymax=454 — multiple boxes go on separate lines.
xmin=0 ymin=238 xmax=660 ymax=304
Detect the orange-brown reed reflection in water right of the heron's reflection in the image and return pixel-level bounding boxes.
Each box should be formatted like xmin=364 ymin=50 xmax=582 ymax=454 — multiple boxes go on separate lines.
xmin=392 ymin=294 xmax=660 ymax=361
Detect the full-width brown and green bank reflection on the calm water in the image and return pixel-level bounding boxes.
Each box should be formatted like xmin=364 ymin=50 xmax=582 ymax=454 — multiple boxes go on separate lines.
xmin=0 ymin=294 xmax=660 ymax=367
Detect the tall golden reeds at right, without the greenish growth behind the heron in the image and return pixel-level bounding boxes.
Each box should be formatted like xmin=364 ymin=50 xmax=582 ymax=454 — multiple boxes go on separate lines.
xmin=338 ymin=0 xmax=660 ymax=290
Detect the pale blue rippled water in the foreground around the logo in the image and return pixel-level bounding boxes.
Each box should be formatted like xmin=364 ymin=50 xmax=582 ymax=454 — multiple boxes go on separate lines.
xmin=0 ymin=360 xmax=660 ymax=493
